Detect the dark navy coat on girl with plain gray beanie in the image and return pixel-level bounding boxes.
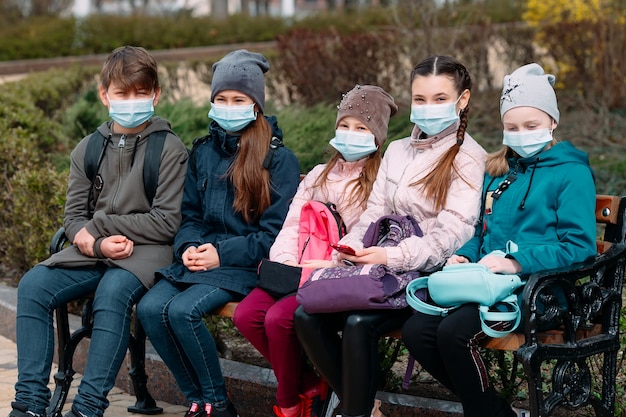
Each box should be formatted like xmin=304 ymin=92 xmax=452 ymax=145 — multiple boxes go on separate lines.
xmin=157 ymin=116 xmax=300 ymax=295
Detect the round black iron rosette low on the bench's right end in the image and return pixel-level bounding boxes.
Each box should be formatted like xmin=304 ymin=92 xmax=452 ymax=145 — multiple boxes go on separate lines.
xmin=552 ymin=360 xmax=591 ymax=407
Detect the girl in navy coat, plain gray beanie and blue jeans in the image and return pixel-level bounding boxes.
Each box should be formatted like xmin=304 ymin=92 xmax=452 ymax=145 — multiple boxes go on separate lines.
xmin=137 ymin=49 xmax=300 ymax=417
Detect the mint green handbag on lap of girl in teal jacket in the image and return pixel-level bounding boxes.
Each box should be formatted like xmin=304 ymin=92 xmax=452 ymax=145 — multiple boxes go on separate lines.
xmin=406 ymin=263 xmax=524 ymax=337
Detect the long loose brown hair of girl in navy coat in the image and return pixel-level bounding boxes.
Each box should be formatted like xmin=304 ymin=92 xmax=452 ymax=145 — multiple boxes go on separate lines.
xmin=226 ymin=111 xmax=272 ymax=223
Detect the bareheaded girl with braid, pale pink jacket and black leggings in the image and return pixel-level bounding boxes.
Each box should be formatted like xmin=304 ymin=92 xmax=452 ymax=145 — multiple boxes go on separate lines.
xmin=295 ymin=56 xmax=486 ymax=417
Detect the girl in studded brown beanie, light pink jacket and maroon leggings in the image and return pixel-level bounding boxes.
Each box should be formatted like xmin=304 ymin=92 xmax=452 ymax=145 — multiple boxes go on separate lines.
xmin=234 ymin=85 xmax=398 ymax=417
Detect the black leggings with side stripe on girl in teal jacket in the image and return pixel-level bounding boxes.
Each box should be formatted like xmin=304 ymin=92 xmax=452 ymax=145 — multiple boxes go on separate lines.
xmin=402 ymin=304 xmax=515 ymax=417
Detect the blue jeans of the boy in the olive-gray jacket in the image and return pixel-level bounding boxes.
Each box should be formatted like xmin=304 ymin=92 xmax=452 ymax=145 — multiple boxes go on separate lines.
xmin=15 ymin=265 xmax=146 ymax=417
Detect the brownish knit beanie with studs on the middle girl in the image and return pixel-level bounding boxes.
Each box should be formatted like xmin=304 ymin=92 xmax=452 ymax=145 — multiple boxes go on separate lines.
xmin=335 ymin=84 xmax=398 ymax=147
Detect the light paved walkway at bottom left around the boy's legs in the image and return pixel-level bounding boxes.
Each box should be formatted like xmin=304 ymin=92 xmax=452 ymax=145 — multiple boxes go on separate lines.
xmin=0 ymin=336 xmax=186 ymax=417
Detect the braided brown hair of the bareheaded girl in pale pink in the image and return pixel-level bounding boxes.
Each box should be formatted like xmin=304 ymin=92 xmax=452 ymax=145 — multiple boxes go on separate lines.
xmin=411 ymin=55 xmax=472 ymax=209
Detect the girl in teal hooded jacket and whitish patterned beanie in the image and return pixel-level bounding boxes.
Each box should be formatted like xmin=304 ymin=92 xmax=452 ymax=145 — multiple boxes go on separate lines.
xmin=402 ymin=64 xmax=596 ymax=417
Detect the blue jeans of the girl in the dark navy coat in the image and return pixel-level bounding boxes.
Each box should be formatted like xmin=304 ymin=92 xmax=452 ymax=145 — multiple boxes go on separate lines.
xmin=137 ymin=279 xmax=234 ymax=404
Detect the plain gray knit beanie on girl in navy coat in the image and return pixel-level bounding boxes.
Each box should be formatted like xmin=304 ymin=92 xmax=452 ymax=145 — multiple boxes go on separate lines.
xmin=211 ymin=49 xmax=270 ymax=113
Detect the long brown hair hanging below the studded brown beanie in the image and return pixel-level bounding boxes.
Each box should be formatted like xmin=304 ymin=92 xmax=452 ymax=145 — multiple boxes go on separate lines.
xmin=313 ymin=146 xmax=382 ymax=208
